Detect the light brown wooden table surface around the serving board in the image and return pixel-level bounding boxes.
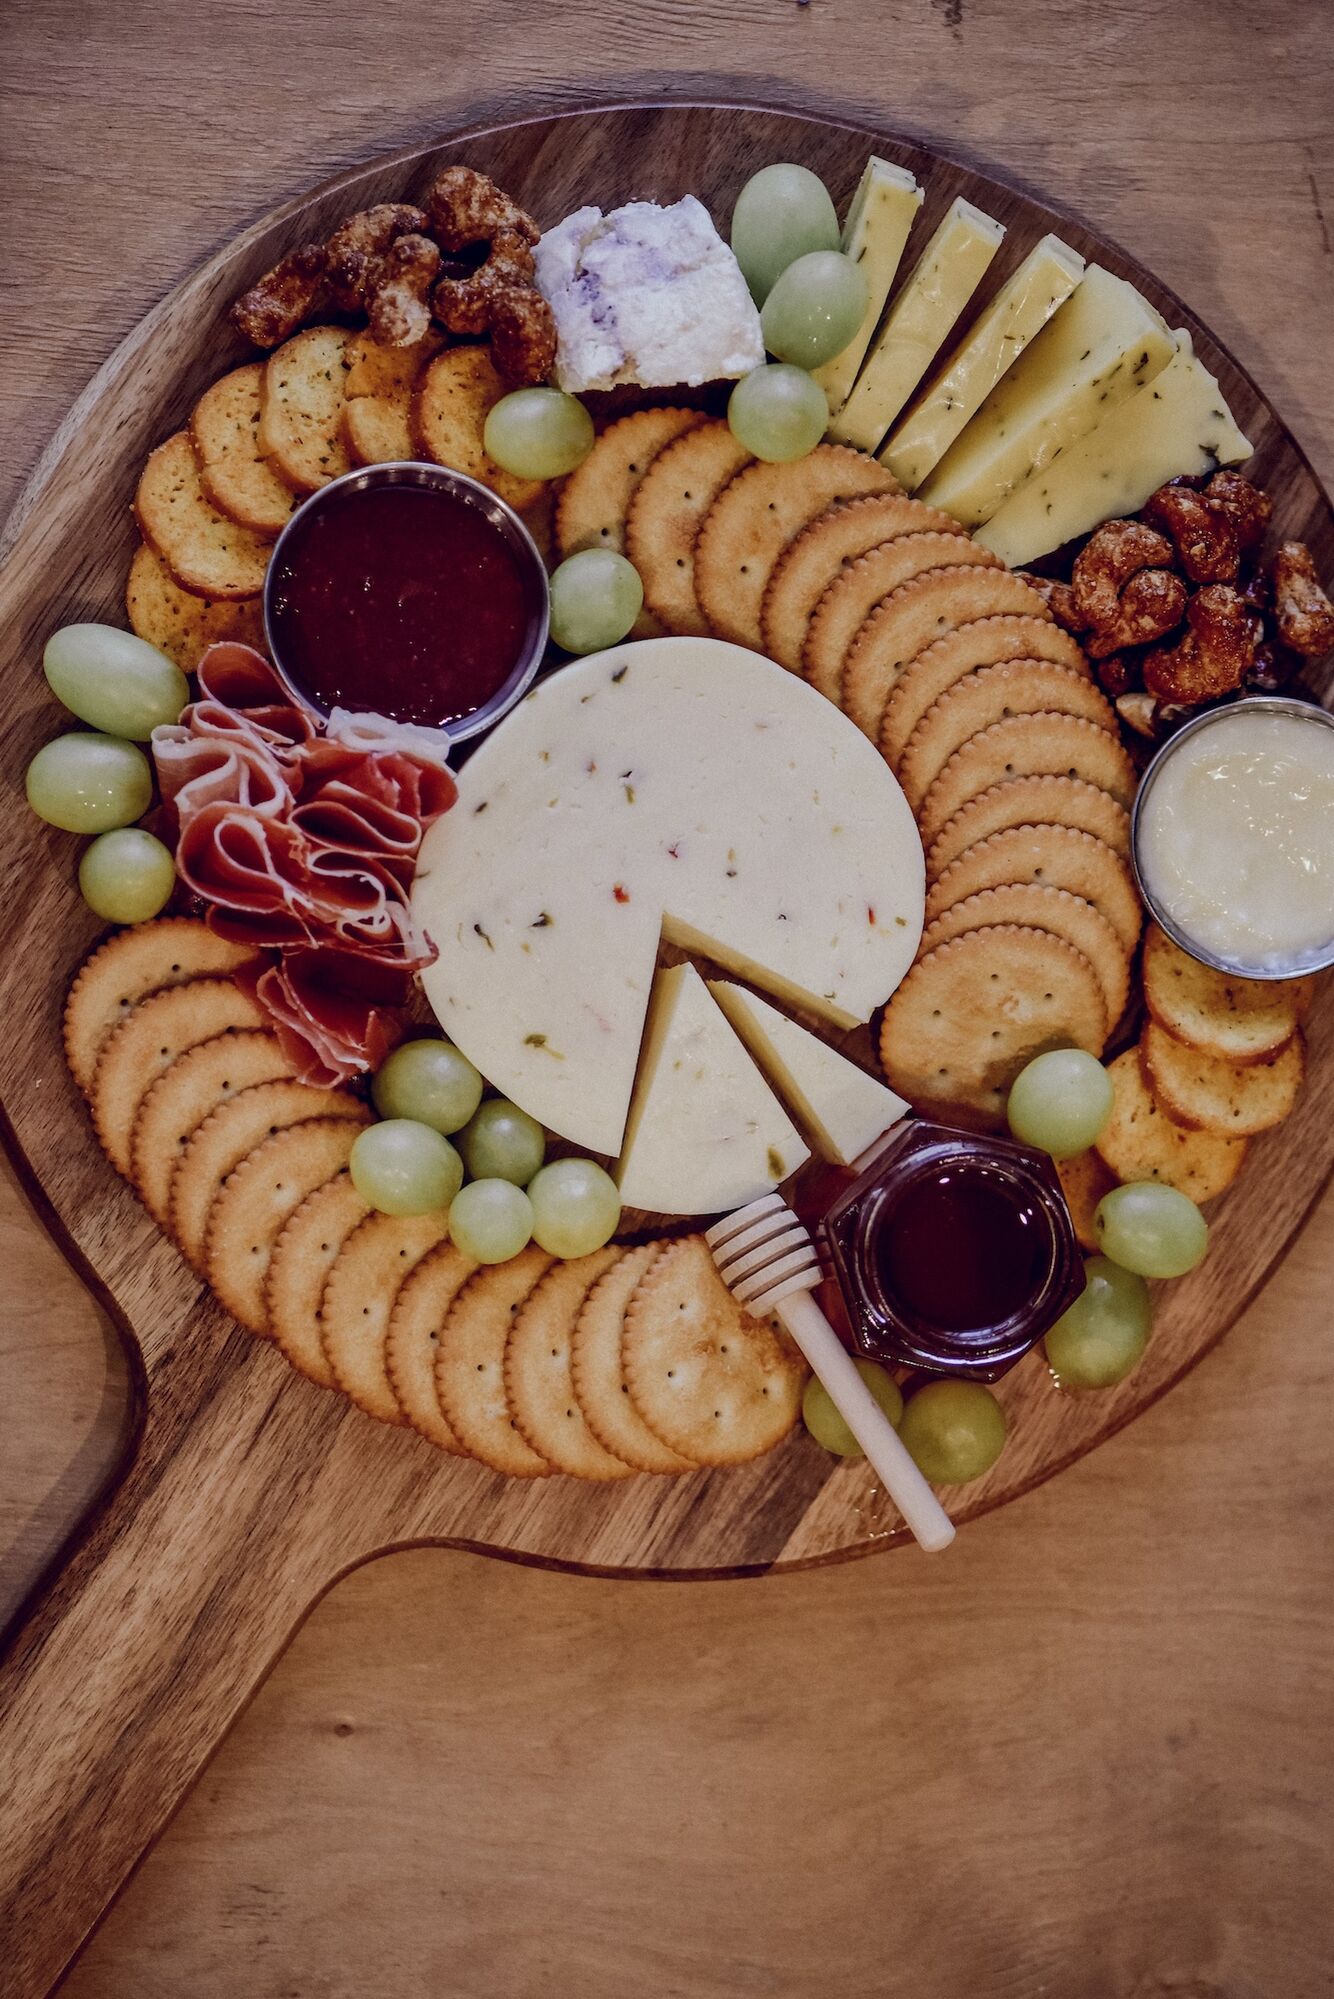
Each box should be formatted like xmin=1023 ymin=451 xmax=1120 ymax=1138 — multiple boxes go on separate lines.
xmin=0 ymin=0 xmax=1334 ymax=1999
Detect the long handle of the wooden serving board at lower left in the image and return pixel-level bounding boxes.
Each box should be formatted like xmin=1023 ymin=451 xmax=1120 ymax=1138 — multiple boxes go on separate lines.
xmin=0 ymin=1353 xmax=356 ymax=1999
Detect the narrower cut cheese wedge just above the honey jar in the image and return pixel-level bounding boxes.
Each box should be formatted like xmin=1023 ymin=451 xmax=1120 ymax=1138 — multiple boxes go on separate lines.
xmin=708 ymin=980 xmax=908 ymax=1165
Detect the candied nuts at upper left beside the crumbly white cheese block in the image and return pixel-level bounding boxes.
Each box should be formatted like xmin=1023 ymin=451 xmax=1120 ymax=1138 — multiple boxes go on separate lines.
xmin=232 ymin=166 xmax=556 ymax=382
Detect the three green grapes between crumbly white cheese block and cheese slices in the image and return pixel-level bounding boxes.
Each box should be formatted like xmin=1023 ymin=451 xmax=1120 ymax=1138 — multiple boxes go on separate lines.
xmin=728 ymin=162 xmax=868 ymax=464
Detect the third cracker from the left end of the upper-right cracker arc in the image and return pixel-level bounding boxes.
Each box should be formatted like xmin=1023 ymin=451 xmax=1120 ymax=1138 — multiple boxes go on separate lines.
xmin=694 ymin=444 xmax=898 ymax=652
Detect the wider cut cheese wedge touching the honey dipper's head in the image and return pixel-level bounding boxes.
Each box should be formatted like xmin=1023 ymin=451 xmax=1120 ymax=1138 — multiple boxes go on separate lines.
xmin=616 ymin=966 xmax=810 ymax=1215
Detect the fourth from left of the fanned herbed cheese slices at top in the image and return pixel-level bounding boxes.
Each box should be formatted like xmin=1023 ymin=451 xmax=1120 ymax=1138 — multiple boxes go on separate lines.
xmin=918 ymin=264 xmax=1176 ymax=528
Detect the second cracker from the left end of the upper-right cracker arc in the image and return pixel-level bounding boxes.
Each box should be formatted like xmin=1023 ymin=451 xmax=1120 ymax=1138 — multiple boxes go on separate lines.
xmin=626 ymin=420 xmax=750 ymax=638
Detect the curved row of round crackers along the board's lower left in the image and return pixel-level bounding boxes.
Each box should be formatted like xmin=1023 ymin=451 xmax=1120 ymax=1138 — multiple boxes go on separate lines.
xmin=64 ymin=918 xmax=806 ymax=1479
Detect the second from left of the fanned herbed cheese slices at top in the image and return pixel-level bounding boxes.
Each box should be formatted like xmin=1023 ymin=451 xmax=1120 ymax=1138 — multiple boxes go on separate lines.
xmin=830 ymin=196 xmax=1006 ymax=452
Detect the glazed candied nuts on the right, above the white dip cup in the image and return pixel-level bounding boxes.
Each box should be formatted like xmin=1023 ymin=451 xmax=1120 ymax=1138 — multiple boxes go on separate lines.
xmin=1030 ymin=472 xmax=1334 ymax=738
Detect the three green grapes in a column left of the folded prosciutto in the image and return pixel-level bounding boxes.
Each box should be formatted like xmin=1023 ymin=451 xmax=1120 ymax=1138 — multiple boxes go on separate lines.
xmin=26 ymin=624 xmax=190 ymax=924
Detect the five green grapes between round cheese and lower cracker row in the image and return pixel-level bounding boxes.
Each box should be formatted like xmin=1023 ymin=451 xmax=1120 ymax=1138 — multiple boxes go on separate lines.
xmin=350 ymin=1039 xmax=620 ymax=1263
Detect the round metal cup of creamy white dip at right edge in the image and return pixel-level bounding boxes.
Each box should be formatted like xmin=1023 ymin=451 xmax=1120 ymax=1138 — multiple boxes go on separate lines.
xmin=1136 ymin=708 xmax=1334 ymax=976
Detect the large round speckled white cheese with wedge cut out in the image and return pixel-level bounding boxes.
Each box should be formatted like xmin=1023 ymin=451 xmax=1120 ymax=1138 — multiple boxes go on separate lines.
xmin=412 ymin=638 xmax=924 ymax=1155
